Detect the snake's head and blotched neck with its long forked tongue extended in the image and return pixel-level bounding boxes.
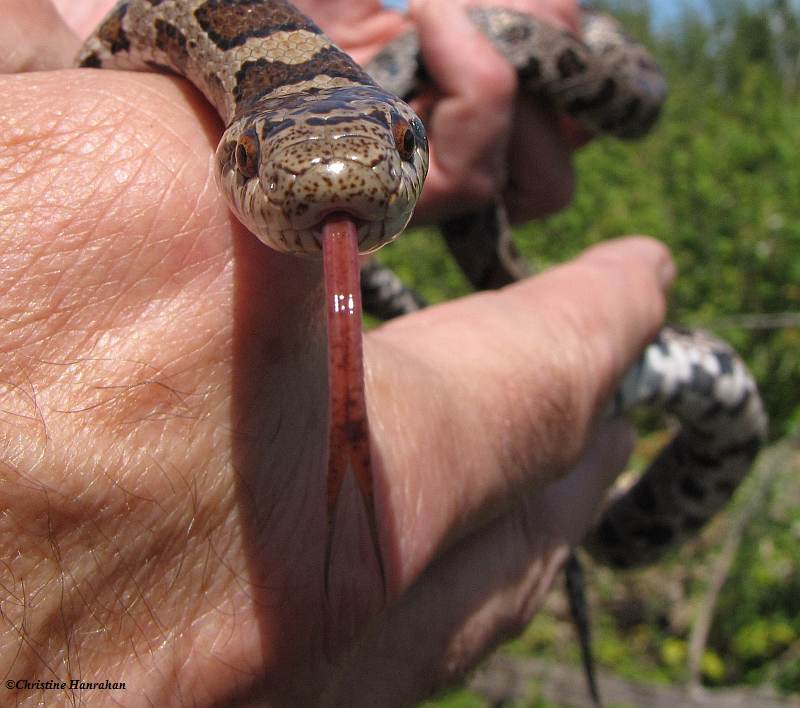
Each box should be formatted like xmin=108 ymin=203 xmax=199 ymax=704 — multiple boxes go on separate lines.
xmin=78 ymin=0 xmax=428 ymax=597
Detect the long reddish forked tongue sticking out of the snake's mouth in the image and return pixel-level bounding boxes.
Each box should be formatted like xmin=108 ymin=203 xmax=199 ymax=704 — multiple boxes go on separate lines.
xmin=322 ymin=214 xmax=386 ymax=596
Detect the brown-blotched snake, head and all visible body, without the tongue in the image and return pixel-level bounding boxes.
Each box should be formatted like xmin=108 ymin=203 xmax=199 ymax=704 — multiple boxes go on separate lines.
xmin=78 ymin=0 xmax=766 ymax=704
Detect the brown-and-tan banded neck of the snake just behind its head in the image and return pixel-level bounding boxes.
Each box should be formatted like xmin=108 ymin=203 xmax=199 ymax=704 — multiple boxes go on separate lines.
xmin=77 ymin=0 xmax=374 ymax=125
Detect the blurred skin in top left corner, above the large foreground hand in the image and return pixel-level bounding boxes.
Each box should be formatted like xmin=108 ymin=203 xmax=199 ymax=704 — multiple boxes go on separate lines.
xmin=0 ymin=0 xmax=80 ymax=73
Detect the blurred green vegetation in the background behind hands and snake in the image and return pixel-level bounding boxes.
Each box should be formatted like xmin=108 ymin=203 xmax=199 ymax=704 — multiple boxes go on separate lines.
xmin=381 ymin=0 xmax=800 ymax=707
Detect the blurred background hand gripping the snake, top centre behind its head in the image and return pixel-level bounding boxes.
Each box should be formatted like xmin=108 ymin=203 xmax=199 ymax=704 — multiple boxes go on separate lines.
xmin=51 ymin=0 xmax=585 ymax=224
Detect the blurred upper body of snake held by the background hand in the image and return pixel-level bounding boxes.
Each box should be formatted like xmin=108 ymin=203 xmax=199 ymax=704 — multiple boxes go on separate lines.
xmin=367 ymin=7 xmax=667 ymax=138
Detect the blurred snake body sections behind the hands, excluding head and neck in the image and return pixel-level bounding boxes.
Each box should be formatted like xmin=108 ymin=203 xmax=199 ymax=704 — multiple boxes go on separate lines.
xmin=362 ymin=7 xmax=767 ymax=568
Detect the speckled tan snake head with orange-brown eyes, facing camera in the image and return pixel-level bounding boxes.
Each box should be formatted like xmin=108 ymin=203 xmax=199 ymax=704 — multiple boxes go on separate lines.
xmin=212 ymin=84 xmax=428 ymax=254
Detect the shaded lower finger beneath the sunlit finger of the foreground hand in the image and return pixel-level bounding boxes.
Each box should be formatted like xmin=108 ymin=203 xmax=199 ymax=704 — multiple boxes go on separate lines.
xmin=328 ymin=421 xmax=631 ymax=705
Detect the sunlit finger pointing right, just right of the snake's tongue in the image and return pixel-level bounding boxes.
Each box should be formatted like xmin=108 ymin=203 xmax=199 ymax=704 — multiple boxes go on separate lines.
xmin=368 ymin=238 xmax=673 ymax=581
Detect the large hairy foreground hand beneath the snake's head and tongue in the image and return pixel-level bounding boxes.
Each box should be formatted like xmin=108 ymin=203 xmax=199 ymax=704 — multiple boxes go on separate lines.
xmin=0 ymin=3 xmax=672 ymax=706
